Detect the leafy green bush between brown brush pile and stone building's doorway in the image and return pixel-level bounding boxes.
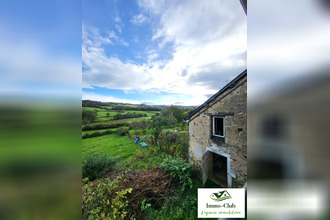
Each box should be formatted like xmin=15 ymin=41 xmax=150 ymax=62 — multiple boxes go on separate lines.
xmin=160 ymin=156 xmax=192 ymax=192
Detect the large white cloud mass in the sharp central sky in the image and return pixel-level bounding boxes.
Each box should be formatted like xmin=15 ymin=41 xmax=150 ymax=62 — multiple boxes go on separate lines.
xmin=82 ymin=0 xmax=246 ymax=104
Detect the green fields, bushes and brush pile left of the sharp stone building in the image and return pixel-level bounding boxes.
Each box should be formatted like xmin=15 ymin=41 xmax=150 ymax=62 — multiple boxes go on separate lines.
xmin=82 ymin=101 xmax=218 ymax=219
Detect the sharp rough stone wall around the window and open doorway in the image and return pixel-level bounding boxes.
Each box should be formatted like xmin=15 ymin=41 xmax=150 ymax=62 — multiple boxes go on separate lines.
xmin=189 ymin=77 xmax=247 ymax=187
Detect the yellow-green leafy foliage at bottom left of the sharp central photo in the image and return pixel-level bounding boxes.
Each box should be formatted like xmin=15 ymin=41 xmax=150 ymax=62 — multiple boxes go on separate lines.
xmin=82 ymin=176 xmax=133 ymax=219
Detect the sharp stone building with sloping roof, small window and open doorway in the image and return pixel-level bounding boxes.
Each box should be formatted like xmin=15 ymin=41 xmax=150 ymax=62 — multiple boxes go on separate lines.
xmin=184 ymin=70 xmax=247 ymax=187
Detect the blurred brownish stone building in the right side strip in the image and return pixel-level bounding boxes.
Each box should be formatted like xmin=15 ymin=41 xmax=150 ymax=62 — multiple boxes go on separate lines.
xmin=248 ymin=68 xmax=330 ymax=183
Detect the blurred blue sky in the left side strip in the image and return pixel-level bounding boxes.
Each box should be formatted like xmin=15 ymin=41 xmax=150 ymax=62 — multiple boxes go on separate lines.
xmin=0 ymin=0 xmax=82 ymax=105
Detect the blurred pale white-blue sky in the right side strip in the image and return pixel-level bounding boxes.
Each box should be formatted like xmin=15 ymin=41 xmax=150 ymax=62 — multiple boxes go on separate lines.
xmin=247 ymin=0 xmax=330 ymax=101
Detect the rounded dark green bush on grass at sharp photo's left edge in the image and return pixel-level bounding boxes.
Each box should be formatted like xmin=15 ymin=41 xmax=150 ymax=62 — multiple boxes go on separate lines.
xmin=82 ymin=154 xmax=117 ymax=181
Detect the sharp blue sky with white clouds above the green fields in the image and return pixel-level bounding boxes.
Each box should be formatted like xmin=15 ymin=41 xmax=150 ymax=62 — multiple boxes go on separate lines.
xmin=82 ymin=0 xmax=247 ymax=105
